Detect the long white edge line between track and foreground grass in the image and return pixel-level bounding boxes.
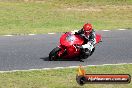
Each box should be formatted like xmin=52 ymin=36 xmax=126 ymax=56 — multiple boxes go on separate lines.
xmin=0 ymin=63 xmax=132 ymax=73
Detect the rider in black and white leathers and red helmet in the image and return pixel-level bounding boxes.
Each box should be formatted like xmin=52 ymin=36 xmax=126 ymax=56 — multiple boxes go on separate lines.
xmin=74 ymin=23 xmax=96 ymax=58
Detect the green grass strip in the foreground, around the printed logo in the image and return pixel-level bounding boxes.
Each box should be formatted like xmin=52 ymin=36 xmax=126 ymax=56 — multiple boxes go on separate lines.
xmin=0 ymin=64 xmax=132 ymax=88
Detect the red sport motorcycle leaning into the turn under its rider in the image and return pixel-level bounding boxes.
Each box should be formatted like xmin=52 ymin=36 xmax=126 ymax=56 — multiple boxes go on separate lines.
xmin=49 ymin=32 xmax=101 ymax=61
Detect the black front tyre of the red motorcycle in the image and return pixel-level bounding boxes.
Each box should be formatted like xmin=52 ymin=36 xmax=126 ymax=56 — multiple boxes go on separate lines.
xmin=49 ymin=47 xmax=60 ymax=61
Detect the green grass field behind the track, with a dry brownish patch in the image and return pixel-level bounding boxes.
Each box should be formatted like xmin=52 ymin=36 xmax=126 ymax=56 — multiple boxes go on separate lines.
xmin=0 ymin=0 xmax=132 ymax=35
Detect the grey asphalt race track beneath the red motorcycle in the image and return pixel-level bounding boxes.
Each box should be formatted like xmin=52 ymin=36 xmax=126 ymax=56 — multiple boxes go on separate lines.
xmin=0 ymin=30 xmax=132 ymax=71
